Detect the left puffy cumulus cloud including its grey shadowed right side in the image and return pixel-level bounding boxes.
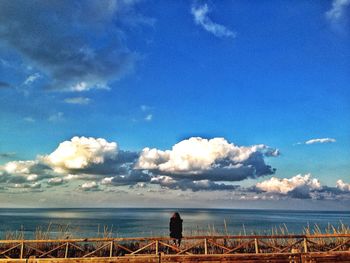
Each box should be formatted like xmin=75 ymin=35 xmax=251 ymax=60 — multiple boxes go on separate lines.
xmin=39 ymin=136 xmax=141 ymax=185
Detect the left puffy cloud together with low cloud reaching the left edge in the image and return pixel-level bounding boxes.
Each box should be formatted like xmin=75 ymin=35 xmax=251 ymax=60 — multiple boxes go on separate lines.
xmin=0 ymin=137 xmax=126 ymax=190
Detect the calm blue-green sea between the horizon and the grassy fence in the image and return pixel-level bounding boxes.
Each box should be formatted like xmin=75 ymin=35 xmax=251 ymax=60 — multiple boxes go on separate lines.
xmin=0 ymin=208 xmax=350 ymax=239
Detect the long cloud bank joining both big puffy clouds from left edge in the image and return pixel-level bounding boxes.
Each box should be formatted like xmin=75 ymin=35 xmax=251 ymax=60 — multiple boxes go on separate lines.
xmin=0 ymin=136 xmax=279 ymax=191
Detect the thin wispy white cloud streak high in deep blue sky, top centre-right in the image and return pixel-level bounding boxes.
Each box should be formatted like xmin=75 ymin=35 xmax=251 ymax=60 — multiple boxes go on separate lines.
xmin=191 ymin=4 xmax=236 ymax=38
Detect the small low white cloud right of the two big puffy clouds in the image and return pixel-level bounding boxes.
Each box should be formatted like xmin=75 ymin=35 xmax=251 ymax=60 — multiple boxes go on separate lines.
xmin=256 ymin=174 xmax=322 ymax=197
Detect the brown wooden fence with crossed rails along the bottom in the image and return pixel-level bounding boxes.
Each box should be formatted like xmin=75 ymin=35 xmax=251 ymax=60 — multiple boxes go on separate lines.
xmin=0 ymin=234 xmax=350 ymax=262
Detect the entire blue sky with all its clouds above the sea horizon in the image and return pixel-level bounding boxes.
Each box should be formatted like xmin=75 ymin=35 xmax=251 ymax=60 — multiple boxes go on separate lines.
xmin=0 ymin=0 xmax=350 ymax=210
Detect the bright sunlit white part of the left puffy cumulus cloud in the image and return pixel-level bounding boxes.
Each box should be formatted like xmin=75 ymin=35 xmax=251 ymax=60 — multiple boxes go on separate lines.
xmin=43 ymin=137 xmax=117 ymax=172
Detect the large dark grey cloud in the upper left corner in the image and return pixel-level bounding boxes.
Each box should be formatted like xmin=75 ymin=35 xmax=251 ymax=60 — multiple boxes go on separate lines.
xmin=0 ymin=0 xmax=147 ymax=92
